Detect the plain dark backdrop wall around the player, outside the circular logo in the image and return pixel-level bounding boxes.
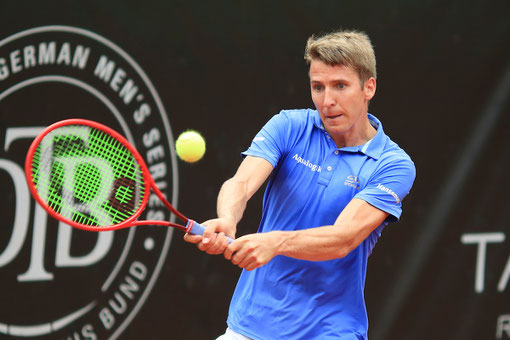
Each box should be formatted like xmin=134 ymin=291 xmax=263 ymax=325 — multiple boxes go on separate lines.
xmin=0 ymin=0 xmax=510 ymax=340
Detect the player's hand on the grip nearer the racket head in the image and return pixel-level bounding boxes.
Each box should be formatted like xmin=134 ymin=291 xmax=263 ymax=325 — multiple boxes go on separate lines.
xmin=184 ymin=218 xmax=237 ymax=255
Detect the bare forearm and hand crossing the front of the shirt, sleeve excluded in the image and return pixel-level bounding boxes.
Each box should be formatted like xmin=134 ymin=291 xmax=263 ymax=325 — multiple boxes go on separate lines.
xmin=224 ymin=198 xmax=388 ymax=270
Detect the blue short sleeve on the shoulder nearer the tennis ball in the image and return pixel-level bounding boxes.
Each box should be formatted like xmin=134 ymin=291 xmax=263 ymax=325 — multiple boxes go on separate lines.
xmin=241 ymin=112 xmax=291 ymax=167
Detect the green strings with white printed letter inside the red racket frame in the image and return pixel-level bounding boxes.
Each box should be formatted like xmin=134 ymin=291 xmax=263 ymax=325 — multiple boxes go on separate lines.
xmin=32 ymin=125 xmax=145 ymax=226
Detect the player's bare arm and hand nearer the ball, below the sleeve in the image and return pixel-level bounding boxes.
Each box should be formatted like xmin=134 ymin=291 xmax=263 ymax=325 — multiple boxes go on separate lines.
xmin=184 ymin=156 xmax=273 ymax=254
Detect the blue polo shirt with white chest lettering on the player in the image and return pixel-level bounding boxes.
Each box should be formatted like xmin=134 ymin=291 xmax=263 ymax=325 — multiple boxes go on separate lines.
xmin=227 ymin=109 xmax=416 ymax=340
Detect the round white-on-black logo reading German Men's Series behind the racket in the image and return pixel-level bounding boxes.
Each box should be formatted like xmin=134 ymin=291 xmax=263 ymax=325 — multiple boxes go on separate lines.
xmin=0 ymin=26 xmax=178 ymax=339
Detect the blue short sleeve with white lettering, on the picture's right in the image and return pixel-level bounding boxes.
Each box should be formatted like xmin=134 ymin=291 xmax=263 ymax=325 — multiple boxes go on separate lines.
xmin=355 ymin=158 xmax=416 ymax=222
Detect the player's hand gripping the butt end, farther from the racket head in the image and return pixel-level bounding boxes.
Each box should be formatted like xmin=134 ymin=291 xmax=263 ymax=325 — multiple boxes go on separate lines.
xmin=223 ymin=232 xmax=279 ymax=271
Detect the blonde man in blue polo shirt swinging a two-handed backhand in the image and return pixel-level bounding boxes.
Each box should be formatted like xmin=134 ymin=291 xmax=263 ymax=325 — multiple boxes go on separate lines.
xmin=185 ymin=31 xmax=415 ymax=340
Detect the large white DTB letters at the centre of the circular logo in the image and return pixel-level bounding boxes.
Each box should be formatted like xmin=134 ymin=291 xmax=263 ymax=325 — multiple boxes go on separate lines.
xmin=0 ymin=127 xmax=113 ymax=281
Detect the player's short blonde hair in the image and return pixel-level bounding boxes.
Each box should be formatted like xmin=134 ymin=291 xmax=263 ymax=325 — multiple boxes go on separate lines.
xmin=305 ymin=30 xmax=377 ymax=87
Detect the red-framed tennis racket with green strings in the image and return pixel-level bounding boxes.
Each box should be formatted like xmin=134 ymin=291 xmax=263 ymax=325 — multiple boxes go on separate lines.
xmin=25 ymin=119 xmax=232 ymax=242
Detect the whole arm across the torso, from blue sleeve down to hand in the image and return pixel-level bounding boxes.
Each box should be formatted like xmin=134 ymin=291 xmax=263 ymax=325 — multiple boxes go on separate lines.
xmin=224 ymin=147 xmax=416 ymax=270
